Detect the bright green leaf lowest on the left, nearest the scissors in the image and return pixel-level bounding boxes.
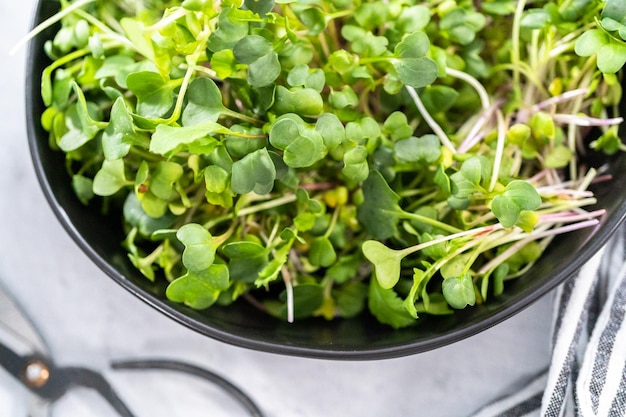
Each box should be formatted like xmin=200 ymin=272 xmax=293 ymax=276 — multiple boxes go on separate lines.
xmin=165 ymin=264 xmax=229 ymax=310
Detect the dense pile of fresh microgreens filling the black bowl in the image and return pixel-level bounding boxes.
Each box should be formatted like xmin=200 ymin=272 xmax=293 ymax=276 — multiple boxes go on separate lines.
xmin=33 ymin=0 xmax=626 ymax=327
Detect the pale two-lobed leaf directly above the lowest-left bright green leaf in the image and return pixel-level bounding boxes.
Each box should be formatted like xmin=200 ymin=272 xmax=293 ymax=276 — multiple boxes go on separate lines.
xmin=176 ymin=223 xmax=217 ymax=272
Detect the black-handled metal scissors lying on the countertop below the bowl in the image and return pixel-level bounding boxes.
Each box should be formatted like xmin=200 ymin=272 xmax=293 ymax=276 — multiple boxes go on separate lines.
xmin=0 ymin=286 xmax=263 ymax=417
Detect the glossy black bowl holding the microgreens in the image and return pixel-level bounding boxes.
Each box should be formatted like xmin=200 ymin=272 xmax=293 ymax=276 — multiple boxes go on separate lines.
xmin=26 ymin=0 xmax=626 ymax=359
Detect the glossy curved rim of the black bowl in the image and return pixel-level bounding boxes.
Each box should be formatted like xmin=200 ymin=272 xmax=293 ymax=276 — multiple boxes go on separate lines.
xmin=25 ymin=0 xmax=626 ymax=360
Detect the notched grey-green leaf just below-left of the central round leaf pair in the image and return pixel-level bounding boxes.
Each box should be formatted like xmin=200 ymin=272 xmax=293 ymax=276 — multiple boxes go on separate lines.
xmin=231 ymin=148 xmax=276 ymax=195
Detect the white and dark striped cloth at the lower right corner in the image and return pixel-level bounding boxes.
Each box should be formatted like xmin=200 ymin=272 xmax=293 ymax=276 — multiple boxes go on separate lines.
xmin=472 ymin=226 xmax=626 ymax=417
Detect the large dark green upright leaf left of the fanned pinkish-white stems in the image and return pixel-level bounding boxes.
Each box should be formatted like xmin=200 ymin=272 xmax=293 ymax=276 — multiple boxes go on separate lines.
xmin=357 ymin=171 xmax=401 ymax=240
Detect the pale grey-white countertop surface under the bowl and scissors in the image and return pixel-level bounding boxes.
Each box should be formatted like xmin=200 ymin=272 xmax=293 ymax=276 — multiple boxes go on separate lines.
xmin=0 ymin=1 xmax=552 ymax=417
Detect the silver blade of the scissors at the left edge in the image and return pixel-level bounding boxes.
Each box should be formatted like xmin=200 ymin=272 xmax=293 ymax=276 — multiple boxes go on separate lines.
xmin=0 ymin=285 xmax=48 ymax=355
